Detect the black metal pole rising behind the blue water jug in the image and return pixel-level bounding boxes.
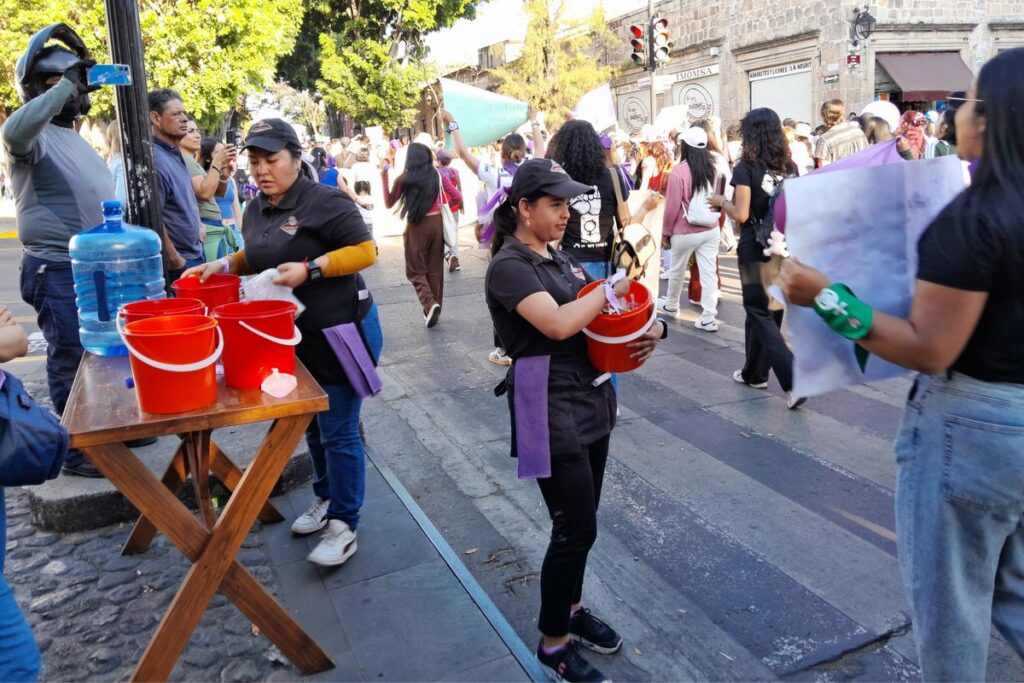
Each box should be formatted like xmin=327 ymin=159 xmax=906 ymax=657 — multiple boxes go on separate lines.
xmin=104 ymin=0 xmax=164 ymax=244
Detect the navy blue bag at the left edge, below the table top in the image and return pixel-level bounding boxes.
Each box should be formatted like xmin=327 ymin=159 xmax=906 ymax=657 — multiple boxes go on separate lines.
xmin=0 ymin=371 xmax=69 ymax=486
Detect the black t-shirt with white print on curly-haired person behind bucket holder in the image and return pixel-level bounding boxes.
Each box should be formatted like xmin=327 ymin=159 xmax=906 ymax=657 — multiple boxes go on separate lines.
xmin=562 ymin=169 xmax=630 ymax=261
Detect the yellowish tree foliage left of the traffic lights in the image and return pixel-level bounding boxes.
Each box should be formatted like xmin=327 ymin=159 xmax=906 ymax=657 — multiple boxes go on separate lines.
xmin=490 ymin=0 xmax=622 ymax=120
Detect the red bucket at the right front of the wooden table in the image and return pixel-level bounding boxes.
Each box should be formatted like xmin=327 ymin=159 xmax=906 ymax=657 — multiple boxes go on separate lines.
xmin=213 ymin=299 xmax=302 ymax=389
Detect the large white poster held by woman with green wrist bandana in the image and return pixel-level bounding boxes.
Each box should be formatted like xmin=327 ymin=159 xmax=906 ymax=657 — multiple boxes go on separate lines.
xmin=785 ymin=157 xmax=965 ymax=396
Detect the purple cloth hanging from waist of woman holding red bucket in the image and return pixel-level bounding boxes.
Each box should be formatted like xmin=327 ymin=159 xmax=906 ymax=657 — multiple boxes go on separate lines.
xmin=512 ymin=355 xmax=551 ymax=479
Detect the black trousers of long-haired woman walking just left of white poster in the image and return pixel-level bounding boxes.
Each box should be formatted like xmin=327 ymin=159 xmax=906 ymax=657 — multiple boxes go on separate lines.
xmin=736 ymin=234 xmax=793 ymax=391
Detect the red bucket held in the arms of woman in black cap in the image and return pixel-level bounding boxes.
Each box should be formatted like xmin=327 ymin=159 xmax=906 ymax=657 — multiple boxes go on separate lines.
xmin=577 ymin=280 xmax=656 ymax=373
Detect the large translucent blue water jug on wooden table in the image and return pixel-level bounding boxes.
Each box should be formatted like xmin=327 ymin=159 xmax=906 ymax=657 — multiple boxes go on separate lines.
xmin=69 ymin=201 xmax=166 ymax=355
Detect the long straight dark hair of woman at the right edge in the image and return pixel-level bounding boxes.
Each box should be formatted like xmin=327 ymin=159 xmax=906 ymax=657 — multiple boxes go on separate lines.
xmin=965 ymin=47 xmax=1024 ymax=230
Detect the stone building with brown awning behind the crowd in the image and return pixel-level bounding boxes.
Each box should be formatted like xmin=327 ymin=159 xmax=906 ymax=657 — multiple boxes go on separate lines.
xmin=609 ymin=0 xmax=1024 ymax=132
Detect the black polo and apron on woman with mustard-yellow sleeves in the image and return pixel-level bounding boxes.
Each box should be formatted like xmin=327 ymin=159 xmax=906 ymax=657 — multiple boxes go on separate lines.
xmin=242 ymin=176 xmax=373 ymax=385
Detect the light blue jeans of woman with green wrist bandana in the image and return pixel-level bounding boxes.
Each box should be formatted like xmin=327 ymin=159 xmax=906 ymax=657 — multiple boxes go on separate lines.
xmin=895 ymin=373 xmax=1024 ymax=681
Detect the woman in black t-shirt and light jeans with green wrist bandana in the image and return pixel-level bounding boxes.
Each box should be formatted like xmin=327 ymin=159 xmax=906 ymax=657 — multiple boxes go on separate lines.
xmin=782 ymin=48 xmax=1024 ymax=681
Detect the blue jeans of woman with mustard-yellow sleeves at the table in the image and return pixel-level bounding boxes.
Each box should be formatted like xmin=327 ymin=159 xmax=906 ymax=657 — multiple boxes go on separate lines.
xmin=306 ymin=303 xmax=384 ymax=531
